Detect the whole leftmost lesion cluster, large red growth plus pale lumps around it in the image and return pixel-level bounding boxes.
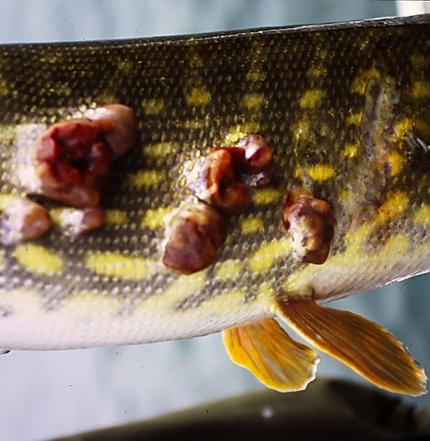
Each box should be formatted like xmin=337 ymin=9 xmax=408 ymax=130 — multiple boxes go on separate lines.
xmin=0 ymin=104 xmax=136 ymax=244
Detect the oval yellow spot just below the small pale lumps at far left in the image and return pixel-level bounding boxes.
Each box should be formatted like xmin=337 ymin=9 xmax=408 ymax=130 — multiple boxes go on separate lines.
xmin=14 ymin=244 xmax=64 ymax=276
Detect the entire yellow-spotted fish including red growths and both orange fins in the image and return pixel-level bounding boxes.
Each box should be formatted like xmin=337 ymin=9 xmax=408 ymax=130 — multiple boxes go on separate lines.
xmin=0 ymin=15 xmax=430 ymax=396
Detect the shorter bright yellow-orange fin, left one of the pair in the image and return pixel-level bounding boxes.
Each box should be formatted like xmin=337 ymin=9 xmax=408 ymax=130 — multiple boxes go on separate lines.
xmin=222 ymin=319 xmax=319 ymax=392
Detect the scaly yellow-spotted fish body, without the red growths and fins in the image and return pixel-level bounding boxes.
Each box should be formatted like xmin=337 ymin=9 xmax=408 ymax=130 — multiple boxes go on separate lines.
xmin=0 ymin=15 xmax=430 ymax=392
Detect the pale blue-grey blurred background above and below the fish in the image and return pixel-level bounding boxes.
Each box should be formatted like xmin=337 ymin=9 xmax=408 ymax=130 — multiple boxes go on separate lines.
xmin=0 ymin=0 xmax=430 ymax=441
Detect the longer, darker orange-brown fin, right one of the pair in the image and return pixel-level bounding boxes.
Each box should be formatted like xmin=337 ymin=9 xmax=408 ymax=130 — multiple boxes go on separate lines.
xmin=278 ymin=298 xmax=427 ymax=396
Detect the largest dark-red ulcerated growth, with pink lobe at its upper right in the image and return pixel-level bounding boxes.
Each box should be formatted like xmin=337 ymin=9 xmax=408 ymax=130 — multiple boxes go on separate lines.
xmin=36 ymin=104 xmax=136 ymax=208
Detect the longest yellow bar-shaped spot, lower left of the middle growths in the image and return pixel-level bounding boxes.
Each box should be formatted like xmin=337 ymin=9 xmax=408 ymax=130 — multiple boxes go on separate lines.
xmin=85 ymin=251 xmax=157 ymax=280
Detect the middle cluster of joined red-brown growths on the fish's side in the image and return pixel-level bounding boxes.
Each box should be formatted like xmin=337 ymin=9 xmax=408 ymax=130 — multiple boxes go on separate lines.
xmin=162 ymin=134 xmax=274 ymax=274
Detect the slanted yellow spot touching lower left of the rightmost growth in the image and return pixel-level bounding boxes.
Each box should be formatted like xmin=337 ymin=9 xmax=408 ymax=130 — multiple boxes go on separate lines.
xmin=247 ymin=236 xmax=294 ymax=273
